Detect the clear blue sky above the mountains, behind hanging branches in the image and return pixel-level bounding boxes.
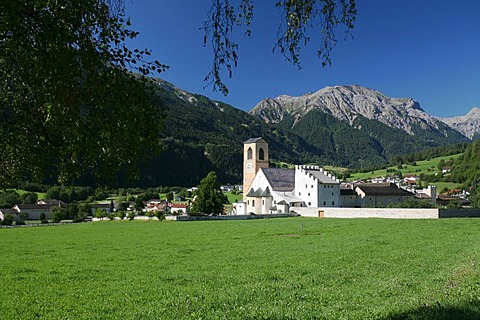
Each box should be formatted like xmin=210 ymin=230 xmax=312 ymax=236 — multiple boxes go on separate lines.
xmin=126 ymin=0 xmax=480 ymax=117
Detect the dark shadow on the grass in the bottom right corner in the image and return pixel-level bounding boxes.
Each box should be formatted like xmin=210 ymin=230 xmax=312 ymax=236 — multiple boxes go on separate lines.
xmin=384 ymin=301 xmax=480 ymax=320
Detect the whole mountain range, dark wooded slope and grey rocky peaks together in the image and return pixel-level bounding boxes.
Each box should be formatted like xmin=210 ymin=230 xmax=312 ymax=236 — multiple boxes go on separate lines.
xmin=125 ymin=79 xmax=480 ymax=186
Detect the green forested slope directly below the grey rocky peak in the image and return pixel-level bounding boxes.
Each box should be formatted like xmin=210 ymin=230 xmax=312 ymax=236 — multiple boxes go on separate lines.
xmin=278 ymin=110 xmax=458 ymax=170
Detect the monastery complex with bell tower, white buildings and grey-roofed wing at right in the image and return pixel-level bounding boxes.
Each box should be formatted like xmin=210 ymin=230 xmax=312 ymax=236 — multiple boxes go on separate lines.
xmin=234 ymin=138 xmax=426 ymax=215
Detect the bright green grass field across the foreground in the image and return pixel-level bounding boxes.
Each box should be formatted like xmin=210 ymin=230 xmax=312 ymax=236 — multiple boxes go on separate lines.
xmin=0 ymin=218 xmax=480 ymax=319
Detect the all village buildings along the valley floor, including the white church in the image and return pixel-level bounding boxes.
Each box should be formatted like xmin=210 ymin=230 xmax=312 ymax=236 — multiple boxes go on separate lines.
xmin=0 ymin=138 xmax=470 ymax=225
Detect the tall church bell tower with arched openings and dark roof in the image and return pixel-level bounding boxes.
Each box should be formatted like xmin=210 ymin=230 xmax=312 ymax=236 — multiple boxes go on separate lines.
xmin=243 ymin=138 xmax=268 ymax=200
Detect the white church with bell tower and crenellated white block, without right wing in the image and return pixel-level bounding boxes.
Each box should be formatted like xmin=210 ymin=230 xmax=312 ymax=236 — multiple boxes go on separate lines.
xmin=234 ymin=138 xmax=340 ymax=214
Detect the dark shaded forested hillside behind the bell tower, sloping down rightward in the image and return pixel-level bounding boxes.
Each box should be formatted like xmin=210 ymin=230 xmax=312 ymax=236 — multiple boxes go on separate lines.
xmin=133 ymin=80 xmax=330 ymax=186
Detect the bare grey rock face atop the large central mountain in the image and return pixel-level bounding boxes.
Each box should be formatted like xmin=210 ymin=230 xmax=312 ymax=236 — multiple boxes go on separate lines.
xmin=249 ymin=85 xmax=448 ymax=135
